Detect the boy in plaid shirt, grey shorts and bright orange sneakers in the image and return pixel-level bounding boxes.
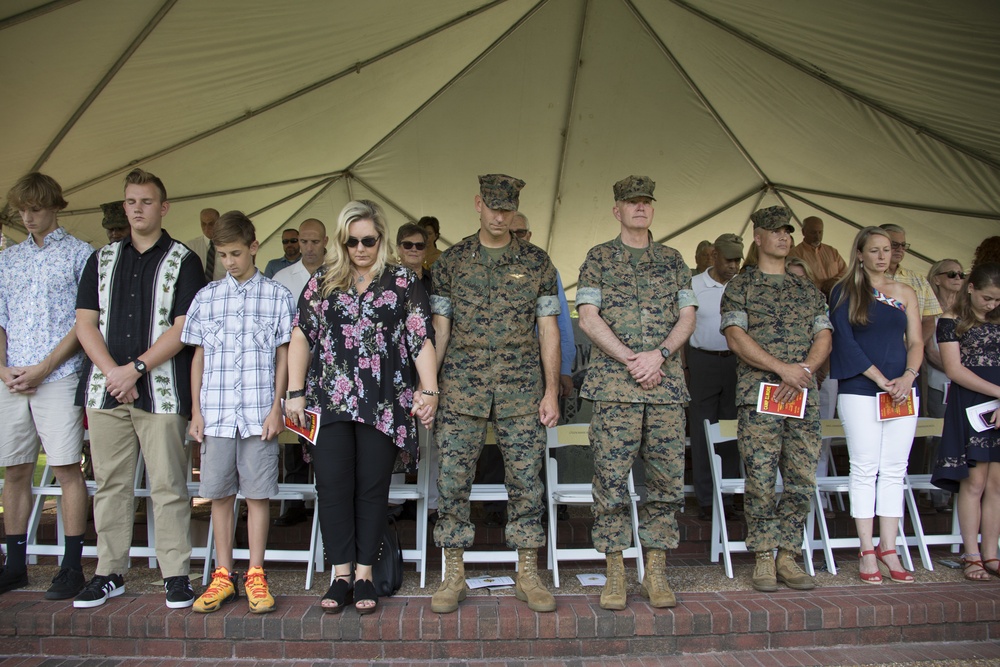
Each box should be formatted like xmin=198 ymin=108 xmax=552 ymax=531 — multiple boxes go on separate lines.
xmin=181 ymin=211 xmax=295 ymax=614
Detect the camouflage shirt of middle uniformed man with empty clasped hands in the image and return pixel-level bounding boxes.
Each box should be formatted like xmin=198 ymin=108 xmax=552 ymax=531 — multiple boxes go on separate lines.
xmin=576 ymin=236 xmax=698 ymax=403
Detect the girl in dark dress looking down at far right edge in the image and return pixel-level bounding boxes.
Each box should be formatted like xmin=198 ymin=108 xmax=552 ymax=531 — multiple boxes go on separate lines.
xmin=931 ymin=264 xmax=1000 ymax=581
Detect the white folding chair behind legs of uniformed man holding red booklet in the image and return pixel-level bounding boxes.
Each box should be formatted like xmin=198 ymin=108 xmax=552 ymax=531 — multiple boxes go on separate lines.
xmin=704 ymin=419 xmax=816 ymax=579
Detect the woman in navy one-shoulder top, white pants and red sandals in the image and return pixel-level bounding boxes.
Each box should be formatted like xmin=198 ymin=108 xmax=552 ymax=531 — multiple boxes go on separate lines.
xmin=830 ymin=227 xmax=923 ymax=584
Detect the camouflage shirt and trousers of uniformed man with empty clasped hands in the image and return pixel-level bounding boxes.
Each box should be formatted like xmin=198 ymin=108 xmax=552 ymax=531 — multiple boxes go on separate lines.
xmin=576 ymin=236 xmax=698 ymax=553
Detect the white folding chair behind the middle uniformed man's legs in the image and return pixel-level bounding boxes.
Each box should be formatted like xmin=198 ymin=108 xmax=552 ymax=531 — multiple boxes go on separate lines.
xmin=545 ymin=424 xmax=644 ymax=588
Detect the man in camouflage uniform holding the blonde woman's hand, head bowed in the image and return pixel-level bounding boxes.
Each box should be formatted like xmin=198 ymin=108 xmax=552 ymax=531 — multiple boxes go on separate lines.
xmin=431 ymin=174 xmax=559 ymax=613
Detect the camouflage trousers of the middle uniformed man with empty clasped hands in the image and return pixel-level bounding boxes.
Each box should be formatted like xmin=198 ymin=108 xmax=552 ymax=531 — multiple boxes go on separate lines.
xmin=590 ymin=401 xmax=684 ymax=553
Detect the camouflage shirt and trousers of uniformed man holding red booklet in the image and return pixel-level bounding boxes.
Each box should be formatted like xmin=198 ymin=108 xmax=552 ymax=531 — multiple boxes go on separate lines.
xmin=719 ymin=266 xmax=833 ymax=552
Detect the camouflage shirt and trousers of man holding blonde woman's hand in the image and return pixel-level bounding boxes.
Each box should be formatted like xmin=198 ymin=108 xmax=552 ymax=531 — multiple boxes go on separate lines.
xmin=431 ymin=234 xmax=559 ymax=549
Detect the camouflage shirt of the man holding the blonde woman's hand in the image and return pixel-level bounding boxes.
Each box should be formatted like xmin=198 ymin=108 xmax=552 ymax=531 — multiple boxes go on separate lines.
xmin=431 ymin=234 xmax=559 ymax=419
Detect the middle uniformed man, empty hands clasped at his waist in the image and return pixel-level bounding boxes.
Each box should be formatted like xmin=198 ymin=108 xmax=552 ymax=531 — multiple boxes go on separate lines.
xmin=576 ymin=176 xmax=698 ymax=609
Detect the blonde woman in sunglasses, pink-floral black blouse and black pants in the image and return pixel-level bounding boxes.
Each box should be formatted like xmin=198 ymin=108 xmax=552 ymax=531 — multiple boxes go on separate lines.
xmin=285 ymin=200 xmax=438 ymax=614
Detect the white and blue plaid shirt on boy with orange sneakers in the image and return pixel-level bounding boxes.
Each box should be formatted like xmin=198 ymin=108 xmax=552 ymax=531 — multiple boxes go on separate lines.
xmin=181 ymin=271 xmax=295 ymax=438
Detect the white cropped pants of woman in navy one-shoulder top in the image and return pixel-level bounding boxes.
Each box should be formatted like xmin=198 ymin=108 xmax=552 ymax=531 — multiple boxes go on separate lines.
xmin=837 ymin=394 xmax=920 ymax=519
